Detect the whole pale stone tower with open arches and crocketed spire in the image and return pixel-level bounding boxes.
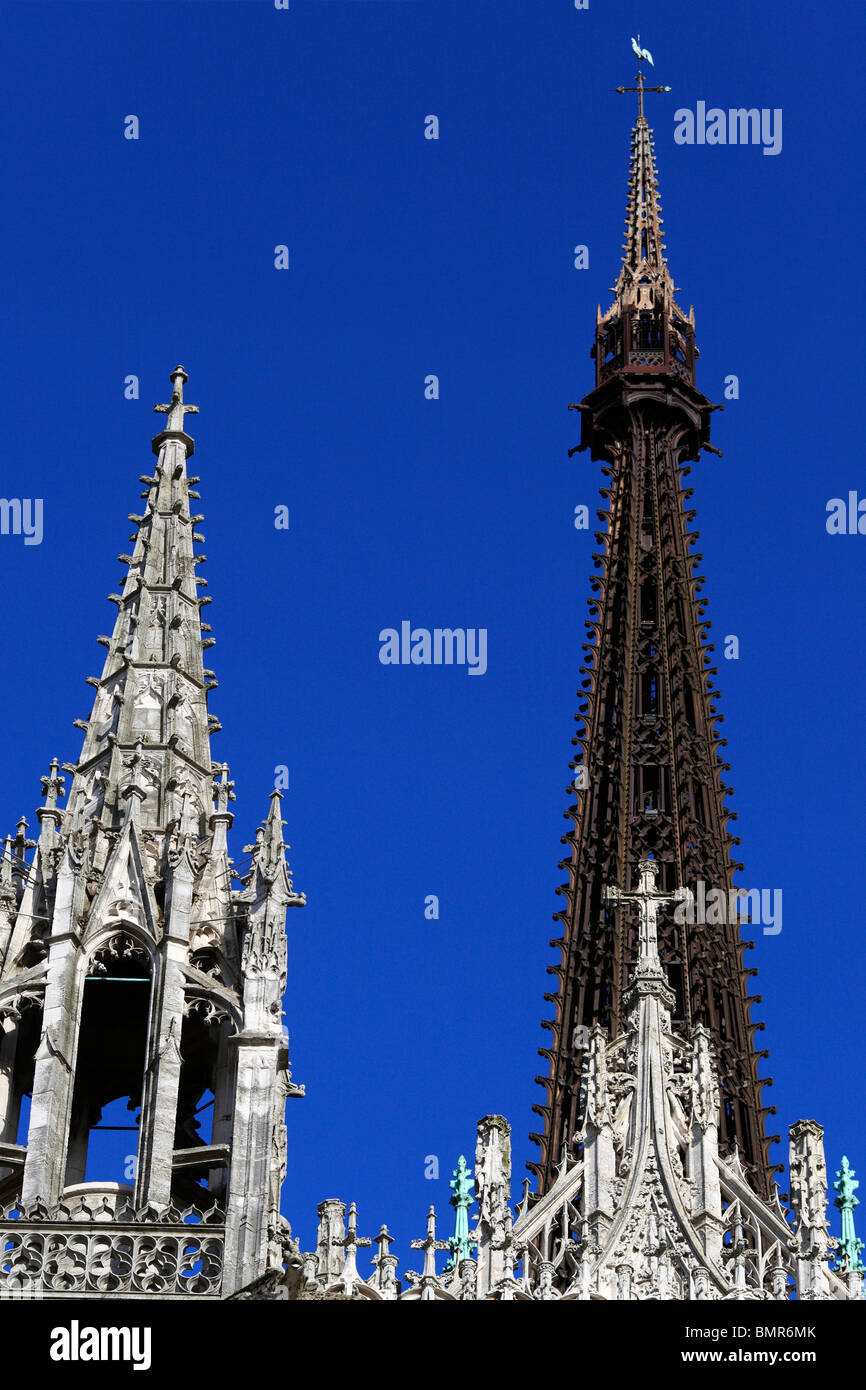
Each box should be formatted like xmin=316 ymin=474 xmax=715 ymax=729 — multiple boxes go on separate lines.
xmin=0 ymin=367 xmax=303 ymax=1294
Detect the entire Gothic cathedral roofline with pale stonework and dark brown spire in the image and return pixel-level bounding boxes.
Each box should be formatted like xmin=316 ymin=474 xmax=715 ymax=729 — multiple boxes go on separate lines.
xmin=0 ymin=67 xmax=863 ymax=1301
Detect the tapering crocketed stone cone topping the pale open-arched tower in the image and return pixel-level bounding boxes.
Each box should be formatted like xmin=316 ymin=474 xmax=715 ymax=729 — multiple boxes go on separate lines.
xmin=70 ymin=367 xmax=217 ymax=833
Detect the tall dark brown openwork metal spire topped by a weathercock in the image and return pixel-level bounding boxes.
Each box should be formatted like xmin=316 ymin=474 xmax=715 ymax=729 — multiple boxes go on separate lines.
xmin=530 ymin=43 xmax=774 ymax=1193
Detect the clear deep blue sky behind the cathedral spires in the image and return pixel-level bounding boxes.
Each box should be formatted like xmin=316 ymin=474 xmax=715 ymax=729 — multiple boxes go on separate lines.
xmin=0 ymin=0 xmax=866 ymax=1254
